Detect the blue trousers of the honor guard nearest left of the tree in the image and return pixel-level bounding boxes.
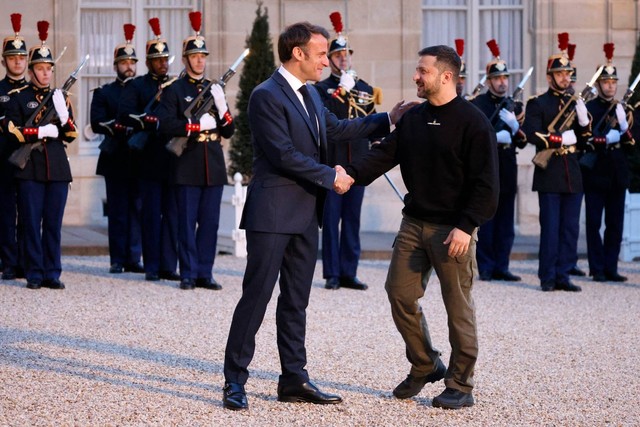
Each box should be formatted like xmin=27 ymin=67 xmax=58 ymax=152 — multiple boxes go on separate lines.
xmin=176 ymin=185 xmax=224 ymax=279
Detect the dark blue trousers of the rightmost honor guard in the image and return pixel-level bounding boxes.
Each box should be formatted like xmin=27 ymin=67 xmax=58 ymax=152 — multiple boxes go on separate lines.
xmin=585 ymin=188 xmax=626 ymax=275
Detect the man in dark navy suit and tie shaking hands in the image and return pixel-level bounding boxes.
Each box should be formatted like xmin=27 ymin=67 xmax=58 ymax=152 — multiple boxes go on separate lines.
xmin=223 ymin=22 xmax=406 ymax=410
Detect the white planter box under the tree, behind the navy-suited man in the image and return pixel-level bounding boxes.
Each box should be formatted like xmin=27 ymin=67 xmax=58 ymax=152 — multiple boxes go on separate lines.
xmin=217 ymin=173 xmax=247 ymax=258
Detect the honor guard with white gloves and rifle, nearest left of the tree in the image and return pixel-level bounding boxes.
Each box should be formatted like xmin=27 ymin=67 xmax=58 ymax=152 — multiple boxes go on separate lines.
xmin=158 ymin=11 xmax=234 ymax=290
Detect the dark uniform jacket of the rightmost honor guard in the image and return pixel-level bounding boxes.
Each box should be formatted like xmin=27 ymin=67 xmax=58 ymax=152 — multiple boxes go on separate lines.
xmin=582 ymin=96 xmax=635 ymax=192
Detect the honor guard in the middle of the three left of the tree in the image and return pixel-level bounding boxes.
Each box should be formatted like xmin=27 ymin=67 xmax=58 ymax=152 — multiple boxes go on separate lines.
xmin=118 ymin=18 xmax=180 ymax=281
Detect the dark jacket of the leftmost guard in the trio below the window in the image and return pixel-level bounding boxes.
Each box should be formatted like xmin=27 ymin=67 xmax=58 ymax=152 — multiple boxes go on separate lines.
xmin=91 ymin=79 xmax=132 ymax=176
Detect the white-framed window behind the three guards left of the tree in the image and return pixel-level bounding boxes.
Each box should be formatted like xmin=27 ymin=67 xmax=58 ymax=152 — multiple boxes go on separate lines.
xmin=76 ymin=0 xmax=204 ymax=155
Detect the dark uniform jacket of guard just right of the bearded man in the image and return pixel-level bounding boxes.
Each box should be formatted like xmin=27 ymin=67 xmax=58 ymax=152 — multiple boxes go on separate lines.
xmin=471 ymin=91 xmax=527 ymax=193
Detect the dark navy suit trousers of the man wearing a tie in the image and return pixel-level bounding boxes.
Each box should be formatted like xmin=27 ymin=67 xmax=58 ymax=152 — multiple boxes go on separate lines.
xmin=224 ymin=220 xmax=318 ymax=385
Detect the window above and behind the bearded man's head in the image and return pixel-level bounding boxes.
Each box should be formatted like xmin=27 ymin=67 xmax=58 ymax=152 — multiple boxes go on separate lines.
xmin=422 ymin=0 xmax=531 ymax=97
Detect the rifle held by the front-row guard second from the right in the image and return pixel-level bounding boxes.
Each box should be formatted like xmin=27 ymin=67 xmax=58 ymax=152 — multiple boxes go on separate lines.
xmin=531 ymin=65 xmax=604 ymax=169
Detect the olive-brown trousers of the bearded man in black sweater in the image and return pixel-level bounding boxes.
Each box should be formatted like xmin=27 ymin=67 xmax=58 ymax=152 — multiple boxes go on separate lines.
xmin=385 ymin=215 xmax=478 ymax=392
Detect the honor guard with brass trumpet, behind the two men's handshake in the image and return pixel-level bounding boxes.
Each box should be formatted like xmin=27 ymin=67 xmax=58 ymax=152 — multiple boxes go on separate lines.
xmin=316 ymin=12 xmax=381 ymax=290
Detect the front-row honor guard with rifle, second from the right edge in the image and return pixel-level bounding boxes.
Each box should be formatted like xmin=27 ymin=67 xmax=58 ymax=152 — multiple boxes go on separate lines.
xmin=522 ymin=33 xmax=591 ymax=292
